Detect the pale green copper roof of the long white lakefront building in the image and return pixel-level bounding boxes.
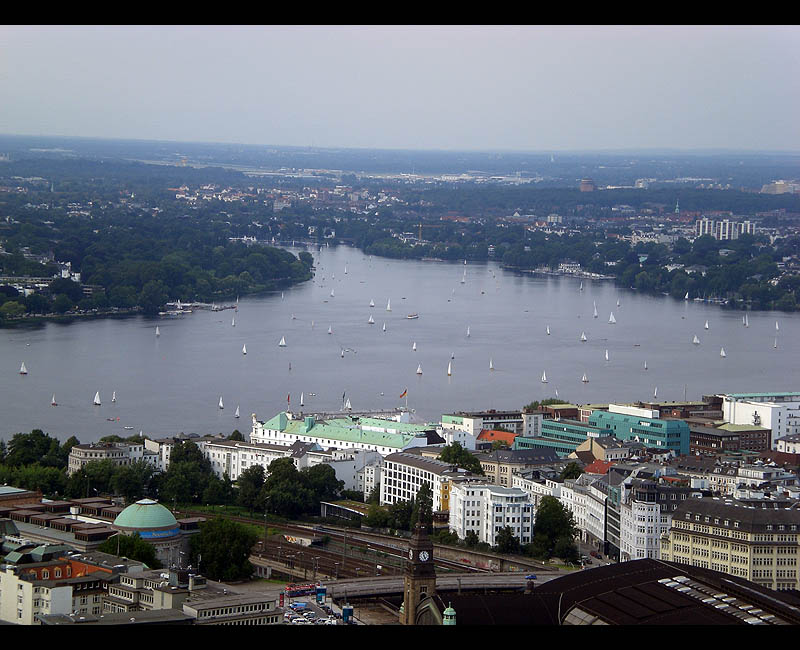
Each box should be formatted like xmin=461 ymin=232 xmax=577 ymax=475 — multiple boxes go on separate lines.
xmin=264 ymin=413 xmax=431 ymax=449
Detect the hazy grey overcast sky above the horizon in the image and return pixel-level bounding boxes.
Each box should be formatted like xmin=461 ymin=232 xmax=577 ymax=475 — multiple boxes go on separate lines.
xmin=0 ymin=26 xmax=800 ymax=151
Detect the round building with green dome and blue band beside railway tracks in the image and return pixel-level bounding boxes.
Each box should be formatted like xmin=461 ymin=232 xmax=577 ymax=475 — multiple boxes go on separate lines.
xmin=112 ymin=499 xmax=184 ymax=566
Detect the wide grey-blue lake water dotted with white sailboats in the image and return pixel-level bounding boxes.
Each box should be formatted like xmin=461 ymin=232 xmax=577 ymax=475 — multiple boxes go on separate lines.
xmin=0 ymin=247 xmax=800 ymax=443
